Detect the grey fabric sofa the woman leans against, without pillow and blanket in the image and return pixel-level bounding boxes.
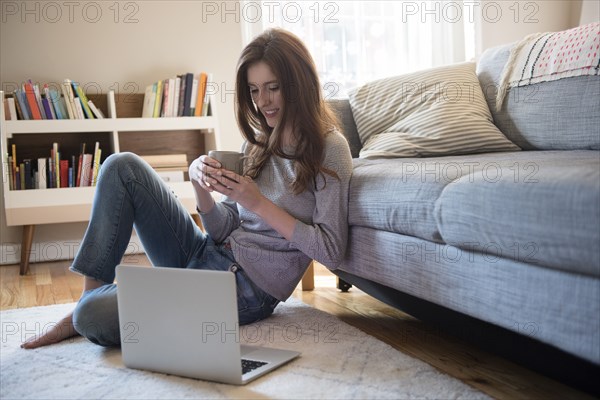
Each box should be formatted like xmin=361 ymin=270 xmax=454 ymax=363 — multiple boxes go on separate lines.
xmin=332 ymin=42 xmax=600 ymax=393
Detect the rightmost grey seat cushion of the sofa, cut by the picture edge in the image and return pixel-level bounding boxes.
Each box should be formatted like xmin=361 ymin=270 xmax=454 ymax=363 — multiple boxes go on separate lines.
xmin=435 ymin=150 xmax=600 ymax=277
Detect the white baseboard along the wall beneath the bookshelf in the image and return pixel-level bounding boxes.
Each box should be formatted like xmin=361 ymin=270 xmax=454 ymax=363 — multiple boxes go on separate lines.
xmin=0 ymin=235 xmax=144 ymax=265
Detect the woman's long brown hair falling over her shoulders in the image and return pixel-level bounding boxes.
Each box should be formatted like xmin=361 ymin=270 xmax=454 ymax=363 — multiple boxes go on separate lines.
xmin=236 ymin=29 xmax=339 ymax=194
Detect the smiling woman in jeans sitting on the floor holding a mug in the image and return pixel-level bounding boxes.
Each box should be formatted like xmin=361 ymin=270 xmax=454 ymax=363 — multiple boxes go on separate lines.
xmin=22 ymin=29 xmax=352 ymax=348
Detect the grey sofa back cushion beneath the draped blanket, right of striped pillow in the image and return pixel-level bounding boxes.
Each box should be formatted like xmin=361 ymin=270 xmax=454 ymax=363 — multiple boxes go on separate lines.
xmin=477 ymin=44 xmax=600 ymax=150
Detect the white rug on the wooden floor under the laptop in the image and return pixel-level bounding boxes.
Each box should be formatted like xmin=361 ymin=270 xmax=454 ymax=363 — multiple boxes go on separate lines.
xmin=0 ymin=299 xmax=487 ymax=400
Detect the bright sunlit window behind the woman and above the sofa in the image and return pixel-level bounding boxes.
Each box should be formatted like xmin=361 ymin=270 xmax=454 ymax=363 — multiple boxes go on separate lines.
xmin=242 ymin=0 xmax=474 ymax=97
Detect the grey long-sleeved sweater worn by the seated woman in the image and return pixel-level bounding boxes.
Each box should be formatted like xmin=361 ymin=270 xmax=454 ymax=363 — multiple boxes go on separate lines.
xmin=201 ymin=132 xmax=352 ymax=301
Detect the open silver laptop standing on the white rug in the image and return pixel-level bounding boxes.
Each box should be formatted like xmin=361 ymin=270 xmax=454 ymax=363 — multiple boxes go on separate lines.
xmin=117 ymin=264 xmax=300 ymax=385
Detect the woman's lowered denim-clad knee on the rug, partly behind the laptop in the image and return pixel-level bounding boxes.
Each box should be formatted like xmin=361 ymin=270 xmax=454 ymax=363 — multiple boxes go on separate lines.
xmin=73 ymin=285 xmax=120 ymax=346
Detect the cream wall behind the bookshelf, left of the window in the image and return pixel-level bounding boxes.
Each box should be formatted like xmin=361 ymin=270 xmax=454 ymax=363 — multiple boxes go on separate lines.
xmin=0 ymin=0 xmax=242 ymax=263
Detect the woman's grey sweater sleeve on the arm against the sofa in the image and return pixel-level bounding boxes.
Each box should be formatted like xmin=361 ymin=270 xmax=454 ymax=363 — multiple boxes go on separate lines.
xmin=291 ymin=132 xmax=352 ymax=269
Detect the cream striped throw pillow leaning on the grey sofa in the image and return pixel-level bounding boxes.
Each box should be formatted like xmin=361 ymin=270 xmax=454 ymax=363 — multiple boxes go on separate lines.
xmin=349 ymin=63 xmax=520 ymax=158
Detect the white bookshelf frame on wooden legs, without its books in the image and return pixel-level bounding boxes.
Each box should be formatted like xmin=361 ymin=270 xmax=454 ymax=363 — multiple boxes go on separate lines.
xmin=0 ymin=91 xmax=218 ymax=274
